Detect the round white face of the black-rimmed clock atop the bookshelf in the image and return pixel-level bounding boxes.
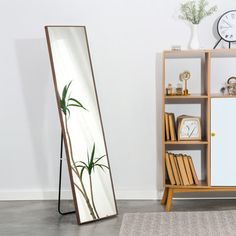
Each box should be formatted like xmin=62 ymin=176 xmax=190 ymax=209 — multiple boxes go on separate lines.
xmin=218 ymin=10 xmax=236 ymax=42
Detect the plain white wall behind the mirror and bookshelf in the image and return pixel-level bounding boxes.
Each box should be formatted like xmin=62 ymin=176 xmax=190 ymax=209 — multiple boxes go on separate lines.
xmin=0 ymin=0 xmax=236 ymax=199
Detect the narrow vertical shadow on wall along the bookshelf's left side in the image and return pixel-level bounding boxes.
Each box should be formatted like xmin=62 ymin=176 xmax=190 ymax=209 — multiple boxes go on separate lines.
xmin=156 ymin=53 xmax=163 ymax=197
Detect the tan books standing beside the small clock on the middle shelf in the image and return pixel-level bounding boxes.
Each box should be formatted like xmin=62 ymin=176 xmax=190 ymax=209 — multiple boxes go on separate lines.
xmin=165 ymin=112 xmax=177 ymax=141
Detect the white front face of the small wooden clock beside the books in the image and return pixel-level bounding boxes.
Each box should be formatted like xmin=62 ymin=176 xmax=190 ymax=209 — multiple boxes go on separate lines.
xmin=179 ymin=118 xmax=201 ymax=139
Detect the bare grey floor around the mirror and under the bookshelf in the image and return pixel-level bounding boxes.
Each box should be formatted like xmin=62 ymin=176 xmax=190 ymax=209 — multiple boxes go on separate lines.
xmin=0 ymin=200 xmax=236 ymax=236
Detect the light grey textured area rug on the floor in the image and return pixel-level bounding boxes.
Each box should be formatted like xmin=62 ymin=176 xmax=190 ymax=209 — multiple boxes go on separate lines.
xmin=120 ymin=211 xmax=236 ymax=236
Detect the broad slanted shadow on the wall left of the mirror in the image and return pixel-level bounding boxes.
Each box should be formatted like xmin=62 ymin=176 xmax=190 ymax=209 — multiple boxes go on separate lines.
xmin=15 ymin=39 xmax=64 ymax=194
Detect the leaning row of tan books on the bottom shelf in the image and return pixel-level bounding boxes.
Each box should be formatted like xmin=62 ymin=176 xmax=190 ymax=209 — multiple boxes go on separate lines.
xmin=165 ymin=152 xmax=199 ymax=186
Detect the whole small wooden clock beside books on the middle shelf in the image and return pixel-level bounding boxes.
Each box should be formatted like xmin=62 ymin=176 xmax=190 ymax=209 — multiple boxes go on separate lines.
xmin=177 ymin=115 xmax=202 ymax=140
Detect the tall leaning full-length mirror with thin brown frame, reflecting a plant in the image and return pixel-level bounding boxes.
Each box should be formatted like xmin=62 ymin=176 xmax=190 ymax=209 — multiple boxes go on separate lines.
xmin=45 ymin=26 xmax=117 ymax=224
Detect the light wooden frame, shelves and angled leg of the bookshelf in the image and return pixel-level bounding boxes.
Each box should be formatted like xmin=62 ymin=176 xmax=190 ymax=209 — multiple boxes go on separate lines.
xmin=162 ymin=49 xmax=236 ymax=211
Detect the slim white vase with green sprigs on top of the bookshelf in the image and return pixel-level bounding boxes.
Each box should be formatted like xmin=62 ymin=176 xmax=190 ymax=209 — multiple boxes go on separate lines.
xmin=179 ymin=0 xmax=217 ymax=49
